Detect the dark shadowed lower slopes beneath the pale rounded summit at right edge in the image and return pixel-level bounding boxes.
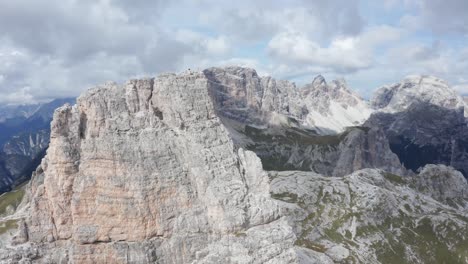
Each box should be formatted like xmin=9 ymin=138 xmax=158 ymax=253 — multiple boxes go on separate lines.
xmin=365 ymin=103 xmax=468 ymax=177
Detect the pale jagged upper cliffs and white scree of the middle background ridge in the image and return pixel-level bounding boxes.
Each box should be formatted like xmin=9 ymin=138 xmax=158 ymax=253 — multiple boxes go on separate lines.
xmin=204 ymin=67 xmax=372 ymax=134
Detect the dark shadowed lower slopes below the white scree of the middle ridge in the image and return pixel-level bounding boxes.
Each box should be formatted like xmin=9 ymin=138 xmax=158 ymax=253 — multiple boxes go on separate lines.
xmin=221 ymin=118 xmax=409 ymax=177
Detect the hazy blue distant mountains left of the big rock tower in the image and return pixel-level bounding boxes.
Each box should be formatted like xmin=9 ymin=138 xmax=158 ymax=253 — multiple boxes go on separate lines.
xmin=0 ymin=98 xmax=75 ymax=194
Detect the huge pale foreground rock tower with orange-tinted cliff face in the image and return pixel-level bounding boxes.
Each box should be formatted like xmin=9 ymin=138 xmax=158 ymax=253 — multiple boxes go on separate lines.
xmin=0 ymin=73 xmax=296 ymax=263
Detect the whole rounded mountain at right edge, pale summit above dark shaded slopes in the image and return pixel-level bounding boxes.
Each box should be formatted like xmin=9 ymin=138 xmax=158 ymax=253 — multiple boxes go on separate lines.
xmin=364 ymin=76 xmax=468 ymax=177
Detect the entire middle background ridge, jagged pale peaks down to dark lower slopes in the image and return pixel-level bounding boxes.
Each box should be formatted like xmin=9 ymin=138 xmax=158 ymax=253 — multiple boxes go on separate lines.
xmin=204 ymin=67 xmax=398 ymax=176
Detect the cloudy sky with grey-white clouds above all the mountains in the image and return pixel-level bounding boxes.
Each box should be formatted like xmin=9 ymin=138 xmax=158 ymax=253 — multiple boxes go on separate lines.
xmin=0 ymin=0 xmax=468 ymax=104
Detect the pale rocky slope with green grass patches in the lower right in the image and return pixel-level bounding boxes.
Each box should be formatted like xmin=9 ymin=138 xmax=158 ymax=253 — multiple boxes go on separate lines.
xmin=269 ymin=167 xmax=468 ymax=263
